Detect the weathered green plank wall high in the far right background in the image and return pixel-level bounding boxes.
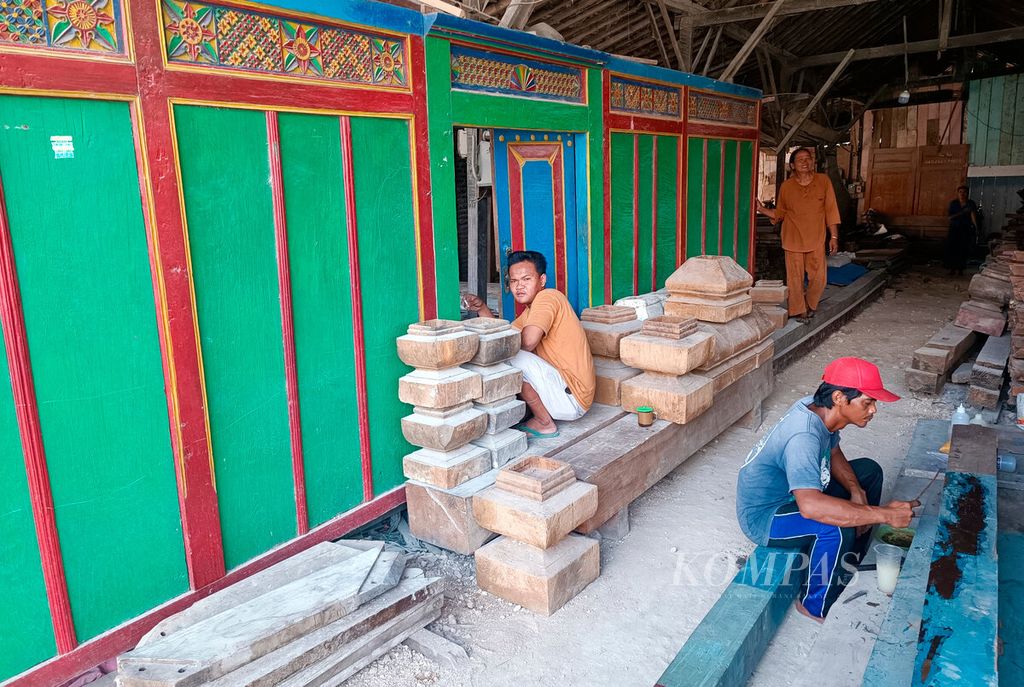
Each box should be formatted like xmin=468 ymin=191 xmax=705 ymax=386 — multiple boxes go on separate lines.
xmin=967 ymin=74 xmax=1024 ymax=167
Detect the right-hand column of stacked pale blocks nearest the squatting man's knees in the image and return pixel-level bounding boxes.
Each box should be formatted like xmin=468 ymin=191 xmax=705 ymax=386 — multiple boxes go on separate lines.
xmin=463 ymin=317 xmax=526 ymax=468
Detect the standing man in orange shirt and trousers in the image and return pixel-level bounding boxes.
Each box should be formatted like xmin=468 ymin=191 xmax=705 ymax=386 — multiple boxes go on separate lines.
xmin=757 ymin=147 xmax=840 ymax=324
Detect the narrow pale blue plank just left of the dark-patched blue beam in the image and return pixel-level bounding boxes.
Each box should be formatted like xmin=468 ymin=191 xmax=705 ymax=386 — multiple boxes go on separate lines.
xmin=862 ymin=515 xmax=938 ymax=687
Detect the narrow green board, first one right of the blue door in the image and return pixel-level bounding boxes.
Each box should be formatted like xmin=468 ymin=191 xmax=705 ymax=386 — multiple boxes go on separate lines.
xmin=606 ymin=133 xmax=634 ymax=300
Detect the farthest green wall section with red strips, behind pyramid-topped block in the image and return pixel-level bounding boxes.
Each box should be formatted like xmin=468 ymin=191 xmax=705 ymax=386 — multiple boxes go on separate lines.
xmin=685 ymin=136 xmax=754 ymax=269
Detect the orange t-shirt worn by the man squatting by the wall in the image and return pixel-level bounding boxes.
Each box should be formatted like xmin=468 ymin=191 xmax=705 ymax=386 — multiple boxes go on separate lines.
xmin=512 ymin=289 xmax=597 ymax=411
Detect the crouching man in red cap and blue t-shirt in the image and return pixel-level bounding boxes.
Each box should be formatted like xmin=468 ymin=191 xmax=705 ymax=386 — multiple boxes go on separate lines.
xmin=736 ymin=357 xmax=919 ymax=622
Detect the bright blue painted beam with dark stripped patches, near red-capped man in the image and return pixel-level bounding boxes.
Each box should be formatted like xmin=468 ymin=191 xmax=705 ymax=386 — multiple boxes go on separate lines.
xmin=912 ymin=472 xmax=998 ymax=687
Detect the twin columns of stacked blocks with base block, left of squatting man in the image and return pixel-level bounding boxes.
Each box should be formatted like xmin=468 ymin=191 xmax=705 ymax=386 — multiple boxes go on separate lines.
xmin=397 ymin=317 xmax=527 ymax=555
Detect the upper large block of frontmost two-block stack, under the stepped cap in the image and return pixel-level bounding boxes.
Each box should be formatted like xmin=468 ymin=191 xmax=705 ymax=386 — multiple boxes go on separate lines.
xmin=473 ymin=479 xmax=597 ymax=549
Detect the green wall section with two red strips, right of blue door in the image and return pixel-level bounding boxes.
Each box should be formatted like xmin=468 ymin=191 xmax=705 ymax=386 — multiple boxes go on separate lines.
xmin=608 ymin=131 xmax=680 ymax=299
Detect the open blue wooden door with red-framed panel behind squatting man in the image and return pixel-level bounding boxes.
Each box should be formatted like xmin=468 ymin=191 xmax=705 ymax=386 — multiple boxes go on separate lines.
xmin=493 ymin=129 xmax=586 ymax=319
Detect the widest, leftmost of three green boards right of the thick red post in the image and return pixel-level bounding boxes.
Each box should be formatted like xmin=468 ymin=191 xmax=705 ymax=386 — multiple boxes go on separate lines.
xmin=174 ymin=105 xmax=297 ymax=568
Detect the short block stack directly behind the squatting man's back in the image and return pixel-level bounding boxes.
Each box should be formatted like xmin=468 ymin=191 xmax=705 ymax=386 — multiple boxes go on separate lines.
xmin=580 ymin=305 xmax=642 ymax=405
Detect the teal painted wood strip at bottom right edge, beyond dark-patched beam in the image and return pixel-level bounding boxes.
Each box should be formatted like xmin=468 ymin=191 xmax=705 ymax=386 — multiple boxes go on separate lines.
xmin=998 ymin=532 xmax=1024 ymax=687
